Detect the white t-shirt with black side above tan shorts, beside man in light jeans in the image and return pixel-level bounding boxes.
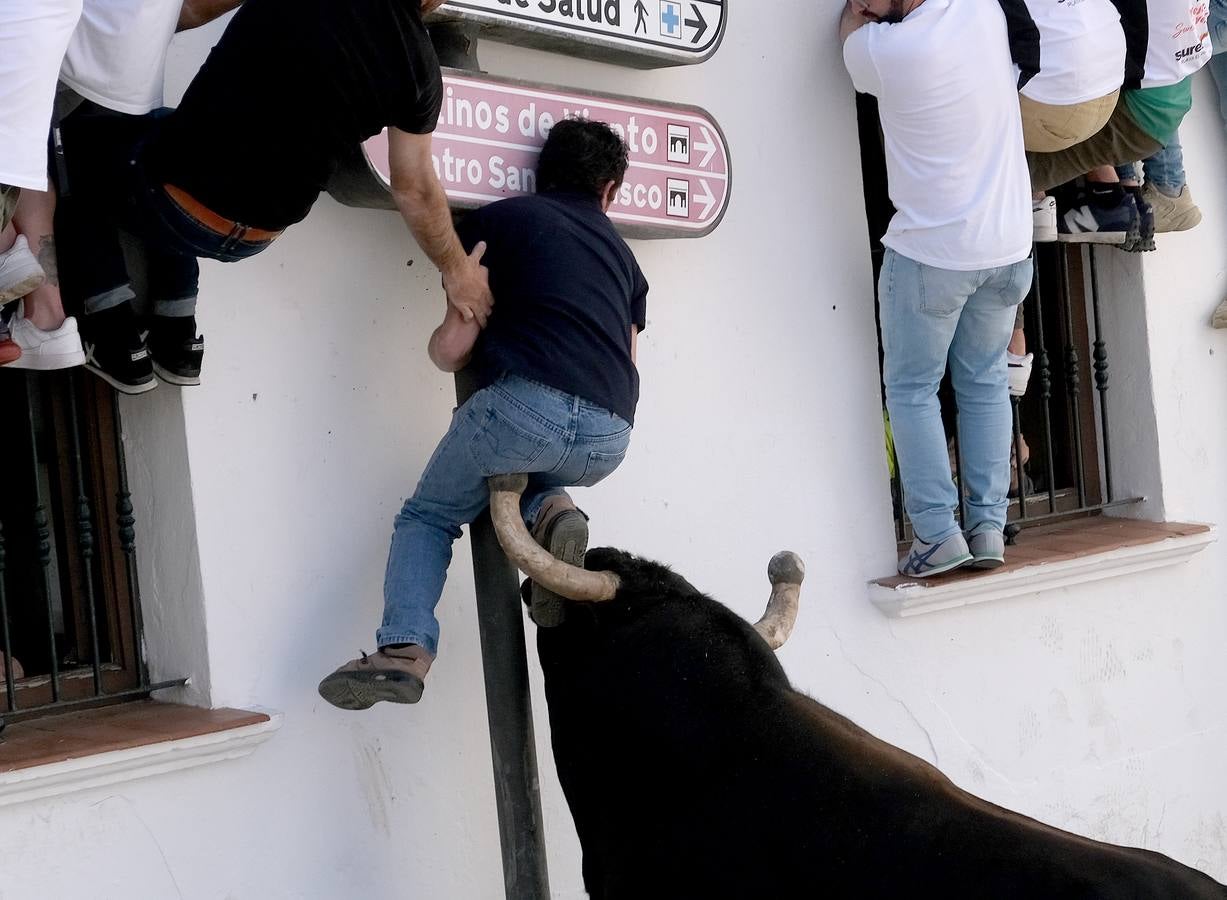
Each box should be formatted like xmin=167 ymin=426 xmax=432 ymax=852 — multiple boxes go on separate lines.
xmin=1021 ymin=0 xmax=1125 ymax=106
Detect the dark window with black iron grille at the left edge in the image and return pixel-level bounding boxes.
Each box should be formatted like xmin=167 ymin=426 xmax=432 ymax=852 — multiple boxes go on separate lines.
xmin=0 ymin=370 xmax=185 ymax=727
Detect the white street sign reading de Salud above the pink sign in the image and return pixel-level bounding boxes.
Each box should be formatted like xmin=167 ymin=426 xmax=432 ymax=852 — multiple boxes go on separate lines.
xmin=428 ymin=0 xmax=728 ymax=69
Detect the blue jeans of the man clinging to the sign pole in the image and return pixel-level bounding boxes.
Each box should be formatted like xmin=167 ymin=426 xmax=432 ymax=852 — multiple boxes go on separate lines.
xmin=375 ymin=374 xmax=631 ymax=653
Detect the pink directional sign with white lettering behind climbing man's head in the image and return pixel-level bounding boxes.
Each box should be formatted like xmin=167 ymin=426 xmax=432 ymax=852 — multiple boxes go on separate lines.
xmin=364 ymin=70 xmax=730 ymax=237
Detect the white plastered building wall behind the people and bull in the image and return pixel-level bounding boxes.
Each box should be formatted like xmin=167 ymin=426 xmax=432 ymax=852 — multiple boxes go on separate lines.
xmin=0 ymin=0 xmax=1227 ymax=900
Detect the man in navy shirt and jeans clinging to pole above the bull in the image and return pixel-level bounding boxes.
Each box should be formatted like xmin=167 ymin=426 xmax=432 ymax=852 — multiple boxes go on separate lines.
xmin=319 ymin=119 xmax=648 ymax=710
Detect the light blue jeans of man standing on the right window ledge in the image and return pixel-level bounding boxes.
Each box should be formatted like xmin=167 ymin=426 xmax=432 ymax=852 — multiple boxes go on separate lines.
xmin=877 ymin=249 xmax=1032 ymax=544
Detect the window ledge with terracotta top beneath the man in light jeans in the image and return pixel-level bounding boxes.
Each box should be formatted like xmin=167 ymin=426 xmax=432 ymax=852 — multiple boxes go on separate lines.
xmin=869 ymin=517 xmax=1217 ymax=619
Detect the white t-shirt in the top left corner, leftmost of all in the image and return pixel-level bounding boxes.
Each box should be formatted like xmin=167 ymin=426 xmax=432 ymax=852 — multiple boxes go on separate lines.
xmin=0 ymin=0 xmax=81 ymax=190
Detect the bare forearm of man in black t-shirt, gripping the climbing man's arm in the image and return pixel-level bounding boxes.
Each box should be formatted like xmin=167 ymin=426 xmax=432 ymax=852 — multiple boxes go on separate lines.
xmin=388 ymin=128 xmax=494 ymax=327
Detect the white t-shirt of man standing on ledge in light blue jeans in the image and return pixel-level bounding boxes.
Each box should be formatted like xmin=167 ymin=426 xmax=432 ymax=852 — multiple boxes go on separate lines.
xmin=844 ymin=0 xmax=1032 ymax=271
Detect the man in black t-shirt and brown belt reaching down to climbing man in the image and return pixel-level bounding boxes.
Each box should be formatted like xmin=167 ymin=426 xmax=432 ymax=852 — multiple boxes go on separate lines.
xmin=63 ymin=0 xmax=492 ymax=393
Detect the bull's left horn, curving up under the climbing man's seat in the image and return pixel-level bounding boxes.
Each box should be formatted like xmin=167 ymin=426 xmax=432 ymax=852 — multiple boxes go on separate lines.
xmin=490 ymin=475 xmax=621 ymax=600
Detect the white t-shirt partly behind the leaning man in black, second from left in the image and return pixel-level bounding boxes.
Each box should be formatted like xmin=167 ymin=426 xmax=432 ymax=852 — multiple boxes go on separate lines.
xmin=60 ymin=0 xmax=183 ymax=115
